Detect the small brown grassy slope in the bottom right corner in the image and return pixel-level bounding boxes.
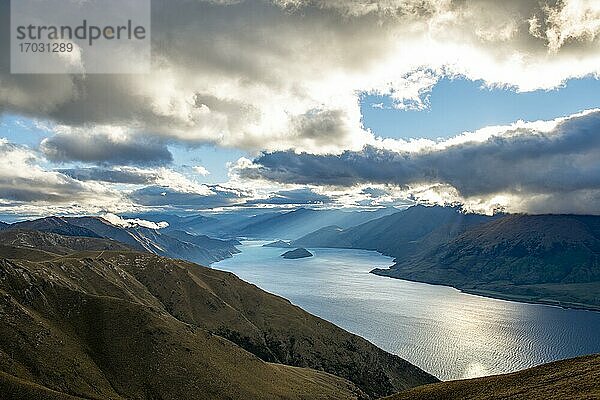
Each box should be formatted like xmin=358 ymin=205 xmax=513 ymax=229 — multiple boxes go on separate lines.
xmin=386 ymin=355 xmax=600 ymax=400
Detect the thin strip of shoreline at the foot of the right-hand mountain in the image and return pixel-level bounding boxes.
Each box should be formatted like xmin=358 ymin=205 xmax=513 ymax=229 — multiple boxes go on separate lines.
xmin=369 ymin=268 xmax=600 ymax=312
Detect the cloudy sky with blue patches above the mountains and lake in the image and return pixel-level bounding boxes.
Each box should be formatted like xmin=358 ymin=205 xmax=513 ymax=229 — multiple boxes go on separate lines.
xmin=0 ymin=0 xmax=600 ymax=219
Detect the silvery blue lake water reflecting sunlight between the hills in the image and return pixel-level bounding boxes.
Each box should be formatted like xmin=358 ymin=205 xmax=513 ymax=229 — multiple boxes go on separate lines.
xmin=213 ymin=242 xmax=600 ymax=380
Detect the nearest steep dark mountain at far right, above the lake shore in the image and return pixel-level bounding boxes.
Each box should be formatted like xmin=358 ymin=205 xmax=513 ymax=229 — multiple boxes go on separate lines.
xmin=374 ymin=215 xmax=600 ymax=307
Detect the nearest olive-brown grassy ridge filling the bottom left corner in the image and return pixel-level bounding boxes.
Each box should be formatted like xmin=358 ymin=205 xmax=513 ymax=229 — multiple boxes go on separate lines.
xmin=0 ymin=261 xmax=360 ymax=399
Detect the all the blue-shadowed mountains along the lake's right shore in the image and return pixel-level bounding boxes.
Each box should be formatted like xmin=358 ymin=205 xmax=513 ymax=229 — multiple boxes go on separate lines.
xmin=292 ymin=206 xmax=600 ymax=308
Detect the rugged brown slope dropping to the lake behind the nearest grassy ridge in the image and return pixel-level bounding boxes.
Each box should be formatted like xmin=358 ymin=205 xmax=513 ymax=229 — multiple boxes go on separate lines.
xmin=96 ymin=253 xmax=437 ymax=397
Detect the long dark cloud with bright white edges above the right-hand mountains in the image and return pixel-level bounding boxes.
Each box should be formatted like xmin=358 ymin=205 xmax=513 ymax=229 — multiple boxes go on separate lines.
xmin=232 ymin=110 xmax=600 ymax=214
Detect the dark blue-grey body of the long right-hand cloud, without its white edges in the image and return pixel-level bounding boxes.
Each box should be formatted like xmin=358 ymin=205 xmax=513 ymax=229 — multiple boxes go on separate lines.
xmin=237 ymin=111 xmax=600 ymax=197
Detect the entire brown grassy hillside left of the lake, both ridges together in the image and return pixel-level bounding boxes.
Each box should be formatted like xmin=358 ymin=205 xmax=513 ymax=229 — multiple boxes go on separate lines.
xmin=0 ymin=229 xmax=436 ymax=400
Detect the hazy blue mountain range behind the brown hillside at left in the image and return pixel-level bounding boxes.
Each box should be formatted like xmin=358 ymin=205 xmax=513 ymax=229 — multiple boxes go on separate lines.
xmin=1 ymin=217 xmax=239 ymax=264
